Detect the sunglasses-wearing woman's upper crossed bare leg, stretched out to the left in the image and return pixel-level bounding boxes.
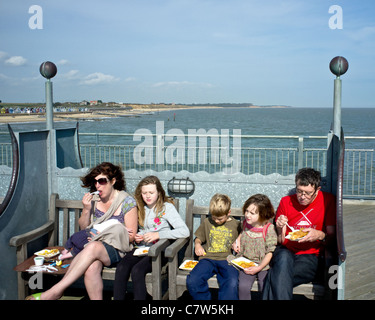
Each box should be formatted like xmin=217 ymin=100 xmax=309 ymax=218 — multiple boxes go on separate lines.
xmin=29 ymin=241 xmax=110 ymax=300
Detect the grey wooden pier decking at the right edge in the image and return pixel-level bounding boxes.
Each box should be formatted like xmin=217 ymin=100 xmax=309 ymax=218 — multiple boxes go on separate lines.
xmin=344 ymin=200 xmax=375 ymax=300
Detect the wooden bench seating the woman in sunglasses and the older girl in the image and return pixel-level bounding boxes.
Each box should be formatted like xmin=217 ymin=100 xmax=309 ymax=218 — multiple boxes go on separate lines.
xmin=9 ymin=194 xmax=178 ymax=300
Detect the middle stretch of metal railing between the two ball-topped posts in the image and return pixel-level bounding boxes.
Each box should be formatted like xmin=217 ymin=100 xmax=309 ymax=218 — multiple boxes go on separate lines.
xmin=80 ymin=133 xmax=327 ymax=175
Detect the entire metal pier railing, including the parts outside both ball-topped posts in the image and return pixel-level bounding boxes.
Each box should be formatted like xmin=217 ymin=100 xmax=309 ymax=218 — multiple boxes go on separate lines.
xmin=0 ymin=133 xmax=375 ymax=199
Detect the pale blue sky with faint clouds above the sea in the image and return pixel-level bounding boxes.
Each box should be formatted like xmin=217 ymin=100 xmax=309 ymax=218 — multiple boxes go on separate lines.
xmin=0 ymin=0 xmax=375 ymax=107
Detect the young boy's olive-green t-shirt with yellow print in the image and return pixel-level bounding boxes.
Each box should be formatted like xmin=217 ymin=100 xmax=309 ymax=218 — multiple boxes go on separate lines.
xmin=195 ymin=217 xmax=241 ymax=260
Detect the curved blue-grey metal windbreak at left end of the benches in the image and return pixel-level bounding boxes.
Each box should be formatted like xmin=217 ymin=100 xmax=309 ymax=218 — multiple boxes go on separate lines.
xmin=0 ymin=125 xmax=82 ymax=300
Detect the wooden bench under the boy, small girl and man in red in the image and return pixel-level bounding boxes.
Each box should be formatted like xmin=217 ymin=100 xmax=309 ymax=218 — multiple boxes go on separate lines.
xmin=165 ymin=199 xmax=325 ymax=300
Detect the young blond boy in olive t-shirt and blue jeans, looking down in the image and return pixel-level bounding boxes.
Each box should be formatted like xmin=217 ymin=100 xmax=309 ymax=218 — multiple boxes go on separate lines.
xmin=186 ymin=194 xmax=241 ymax=300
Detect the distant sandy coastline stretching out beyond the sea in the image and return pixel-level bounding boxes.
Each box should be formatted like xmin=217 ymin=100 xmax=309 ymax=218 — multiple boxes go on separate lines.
xmin=0 ymin=103 xmax=288 ymax=123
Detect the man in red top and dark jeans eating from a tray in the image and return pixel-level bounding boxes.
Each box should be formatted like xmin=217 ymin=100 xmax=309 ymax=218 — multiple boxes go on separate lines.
xmin=262 ymin=168 xmax=336 ymax=300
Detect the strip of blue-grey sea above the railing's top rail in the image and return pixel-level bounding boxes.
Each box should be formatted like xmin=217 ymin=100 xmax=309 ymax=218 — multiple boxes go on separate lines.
xmin=0 ymin=107 xmax=375 ymax=148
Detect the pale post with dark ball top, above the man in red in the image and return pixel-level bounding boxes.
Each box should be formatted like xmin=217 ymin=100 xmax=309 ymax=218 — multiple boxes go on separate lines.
xmin=329 ymin=56 xmax=349 ymax=140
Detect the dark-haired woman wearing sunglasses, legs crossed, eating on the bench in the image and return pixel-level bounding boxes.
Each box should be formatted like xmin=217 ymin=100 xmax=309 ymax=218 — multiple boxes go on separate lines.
xmin=27 ymin=162 xmax=138 ymax=300
